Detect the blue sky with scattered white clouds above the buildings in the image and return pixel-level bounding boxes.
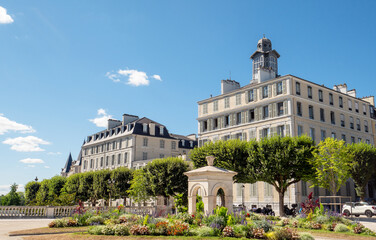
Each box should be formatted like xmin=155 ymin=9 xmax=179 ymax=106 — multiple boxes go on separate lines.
xmin=0 ymin=0 xmax=376 ymax=193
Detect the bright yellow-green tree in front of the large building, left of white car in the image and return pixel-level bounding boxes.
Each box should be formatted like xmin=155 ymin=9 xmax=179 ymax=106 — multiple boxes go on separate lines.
xmin=311 ymin=138 xmax=352 ymax=196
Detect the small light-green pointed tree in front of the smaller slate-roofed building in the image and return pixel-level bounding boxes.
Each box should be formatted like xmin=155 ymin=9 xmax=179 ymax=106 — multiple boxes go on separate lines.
xmin=127 ymin=169 xmax=151 ymax=203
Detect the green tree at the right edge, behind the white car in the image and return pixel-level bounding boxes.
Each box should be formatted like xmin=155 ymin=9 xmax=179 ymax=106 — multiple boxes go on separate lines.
xmin=348 ymin=142 xmax=376 ymax=201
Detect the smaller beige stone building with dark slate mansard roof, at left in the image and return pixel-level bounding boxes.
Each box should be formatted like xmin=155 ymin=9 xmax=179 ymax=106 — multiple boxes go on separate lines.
xmin=62 ymin=114 xmax=197 ymax=176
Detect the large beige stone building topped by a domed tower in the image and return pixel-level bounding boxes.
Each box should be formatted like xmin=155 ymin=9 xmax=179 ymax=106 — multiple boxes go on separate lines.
xmin=197 ymin=38 xmax=376 ymax=213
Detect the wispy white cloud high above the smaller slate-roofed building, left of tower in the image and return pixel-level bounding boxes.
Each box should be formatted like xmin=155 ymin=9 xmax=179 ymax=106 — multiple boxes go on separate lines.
xmin=106 ymin=69 xmax=162 ymax=87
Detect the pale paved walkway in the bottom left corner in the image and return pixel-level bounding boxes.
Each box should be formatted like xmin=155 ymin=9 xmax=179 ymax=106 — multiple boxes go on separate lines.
xmin=0 ymin=218 xmax=51 ymax=240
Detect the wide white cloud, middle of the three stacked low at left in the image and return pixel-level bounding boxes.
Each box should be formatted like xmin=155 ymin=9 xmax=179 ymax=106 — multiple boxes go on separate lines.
xmin=3 ymin=136 xmax=51 ymax=152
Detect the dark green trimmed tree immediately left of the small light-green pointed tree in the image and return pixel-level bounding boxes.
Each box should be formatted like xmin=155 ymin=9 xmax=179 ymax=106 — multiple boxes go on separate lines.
xmin=110 ymin=167 xmax=133 ymax=202
